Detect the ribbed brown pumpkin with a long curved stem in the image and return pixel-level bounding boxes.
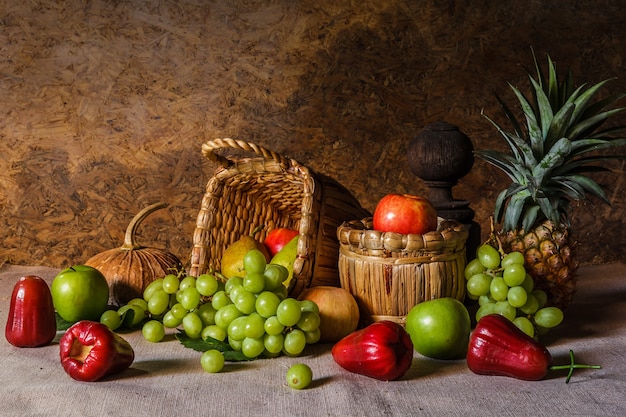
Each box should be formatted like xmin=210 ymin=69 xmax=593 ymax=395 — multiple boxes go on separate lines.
xmin=85 ymin=203 xmax=182 ymax=305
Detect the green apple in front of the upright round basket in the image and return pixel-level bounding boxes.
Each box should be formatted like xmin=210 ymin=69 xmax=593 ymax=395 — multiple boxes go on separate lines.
xmin=406 ymin=297 xmax=471 ymax=359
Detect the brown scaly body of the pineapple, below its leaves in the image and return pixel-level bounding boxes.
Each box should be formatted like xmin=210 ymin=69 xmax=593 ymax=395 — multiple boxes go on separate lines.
xmin=497 ymin=220 xmax=578 ymax=309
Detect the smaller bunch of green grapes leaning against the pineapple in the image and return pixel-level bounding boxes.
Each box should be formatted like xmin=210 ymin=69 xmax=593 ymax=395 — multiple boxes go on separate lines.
xmin=464 ymin=244 xmax=563 ymax=338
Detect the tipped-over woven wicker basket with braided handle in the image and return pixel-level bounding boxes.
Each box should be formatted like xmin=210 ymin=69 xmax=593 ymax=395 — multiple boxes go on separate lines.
xmin=189 ymin=139 xmax=370 ymax=296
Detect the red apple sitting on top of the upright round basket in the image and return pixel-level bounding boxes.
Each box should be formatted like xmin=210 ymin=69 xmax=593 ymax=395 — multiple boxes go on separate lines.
xmin=373 ymin=194 xmax=437 ymax=235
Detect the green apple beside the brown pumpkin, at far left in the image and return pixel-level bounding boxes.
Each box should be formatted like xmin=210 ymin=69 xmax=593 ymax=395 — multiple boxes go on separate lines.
xmin=50 ymin=265 xmax=109 ymax=323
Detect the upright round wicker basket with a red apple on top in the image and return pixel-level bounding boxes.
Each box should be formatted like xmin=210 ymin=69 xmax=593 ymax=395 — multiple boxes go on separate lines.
xmin=337 ymin=218 xmax=468 ymax=325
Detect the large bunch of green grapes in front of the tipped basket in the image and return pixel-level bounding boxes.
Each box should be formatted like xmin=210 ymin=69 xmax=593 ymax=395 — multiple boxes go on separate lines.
xmin=101 ymin=249 xmax=320 ymax=370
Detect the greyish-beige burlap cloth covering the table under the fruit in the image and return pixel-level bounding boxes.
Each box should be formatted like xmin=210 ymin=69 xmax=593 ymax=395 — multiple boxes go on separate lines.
xmin=0 ymin=263 xmax=626 ymax=417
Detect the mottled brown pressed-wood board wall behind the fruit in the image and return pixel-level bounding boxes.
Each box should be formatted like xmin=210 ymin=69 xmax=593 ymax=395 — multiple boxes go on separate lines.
xmin=0 ymin=0 xmax=626 ymax=267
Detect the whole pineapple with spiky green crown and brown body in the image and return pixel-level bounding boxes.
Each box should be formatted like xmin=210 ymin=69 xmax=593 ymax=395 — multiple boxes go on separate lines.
xmin=476 ymin=53 xmax=626 ymax=308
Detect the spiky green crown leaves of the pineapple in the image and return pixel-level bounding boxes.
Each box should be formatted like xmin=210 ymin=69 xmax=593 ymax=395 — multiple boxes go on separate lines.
xmin=475 ymin=51 xmax=626 ymax=230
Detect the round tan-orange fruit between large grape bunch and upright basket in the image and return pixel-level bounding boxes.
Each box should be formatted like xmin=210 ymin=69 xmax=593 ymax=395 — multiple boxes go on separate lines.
xmin=298 ymin=285 xmax=360 ymax=343
